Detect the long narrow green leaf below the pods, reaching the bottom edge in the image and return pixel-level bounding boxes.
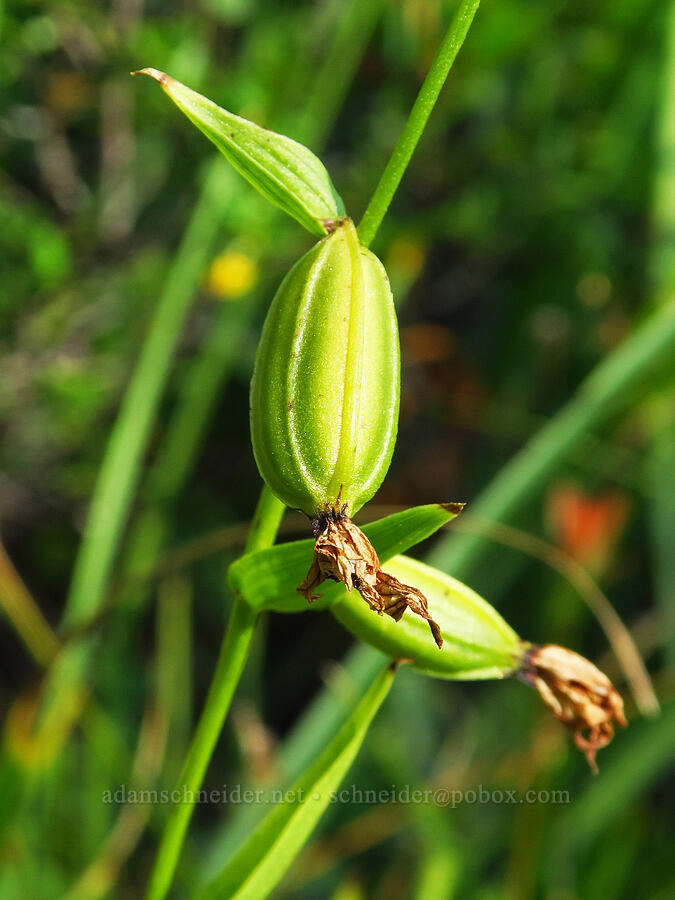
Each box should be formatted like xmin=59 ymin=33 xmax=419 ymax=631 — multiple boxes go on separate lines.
xmin=196 ymin=666 xmax=394 ymax=900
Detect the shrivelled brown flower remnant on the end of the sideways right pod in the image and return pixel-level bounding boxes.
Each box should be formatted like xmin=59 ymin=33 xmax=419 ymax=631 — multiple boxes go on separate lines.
xmin=520 ymin=644 xmax=628 ymax=775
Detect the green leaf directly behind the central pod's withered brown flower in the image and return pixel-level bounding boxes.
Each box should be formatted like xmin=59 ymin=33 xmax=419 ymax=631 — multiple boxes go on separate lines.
xmin=229 ymin=503 xmax=461 ymax=612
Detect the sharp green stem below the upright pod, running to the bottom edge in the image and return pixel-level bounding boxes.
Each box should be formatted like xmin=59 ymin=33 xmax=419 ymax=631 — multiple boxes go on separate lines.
xmin=146 ymin=487 xmax=284 ymax=900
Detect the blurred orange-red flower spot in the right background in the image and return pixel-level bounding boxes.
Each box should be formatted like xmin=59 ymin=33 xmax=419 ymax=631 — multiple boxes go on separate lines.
xmin=546 ymin=482 xmax=629 ymax=571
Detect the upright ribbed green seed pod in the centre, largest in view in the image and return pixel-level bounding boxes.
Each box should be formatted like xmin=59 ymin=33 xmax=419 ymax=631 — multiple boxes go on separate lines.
xmin=251 ymin=219 xmax=400 ymax=516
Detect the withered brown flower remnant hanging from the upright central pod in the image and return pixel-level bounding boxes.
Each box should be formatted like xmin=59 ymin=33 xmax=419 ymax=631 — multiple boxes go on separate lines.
xmin=298 ymin=504 xmax=443 ymax=650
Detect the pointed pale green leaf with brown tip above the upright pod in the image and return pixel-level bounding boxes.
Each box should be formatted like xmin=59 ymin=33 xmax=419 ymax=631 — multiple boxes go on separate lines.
xmin=133 ymin=68 xmax=345 ymax=236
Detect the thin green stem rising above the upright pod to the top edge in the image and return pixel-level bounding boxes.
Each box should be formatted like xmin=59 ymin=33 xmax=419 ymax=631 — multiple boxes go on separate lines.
xmin=358 ymin=0 xmax=480 ymax=247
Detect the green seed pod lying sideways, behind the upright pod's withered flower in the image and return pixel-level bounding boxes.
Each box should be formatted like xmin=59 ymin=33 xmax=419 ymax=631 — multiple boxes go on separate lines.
xmin=331 ymin=556 xmax=523 ymax=679
